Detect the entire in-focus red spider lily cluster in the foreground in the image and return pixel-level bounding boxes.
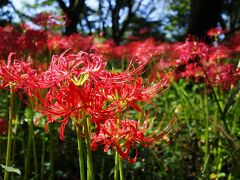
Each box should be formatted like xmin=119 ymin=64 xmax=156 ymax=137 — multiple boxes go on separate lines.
xmin=0 ymin=51 xmax=171 ymax=161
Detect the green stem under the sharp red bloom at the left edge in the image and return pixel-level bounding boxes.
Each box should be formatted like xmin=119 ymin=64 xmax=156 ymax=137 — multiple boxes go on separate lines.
xmin=4 ymin=86 xmax=14 ymax=180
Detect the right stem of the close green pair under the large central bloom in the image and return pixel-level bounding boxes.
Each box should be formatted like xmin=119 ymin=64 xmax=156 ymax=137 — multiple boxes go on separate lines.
xmin=83 ymin=118 xmax=94 ymax=180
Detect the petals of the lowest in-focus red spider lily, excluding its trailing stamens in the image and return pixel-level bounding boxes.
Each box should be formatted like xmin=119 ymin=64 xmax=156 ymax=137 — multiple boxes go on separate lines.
xmin=91 ymin=119 xmax=154 ymax=163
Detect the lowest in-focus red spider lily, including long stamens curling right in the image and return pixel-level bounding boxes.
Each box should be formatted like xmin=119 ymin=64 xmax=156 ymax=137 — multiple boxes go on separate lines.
xmin=91 ymin=116 xmax=176 ymax=163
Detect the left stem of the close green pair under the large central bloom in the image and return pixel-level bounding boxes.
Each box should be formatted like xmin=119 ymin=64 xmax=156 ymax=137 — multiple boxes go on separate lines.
xmin=76 ymin=126 xmax=85 ymax=180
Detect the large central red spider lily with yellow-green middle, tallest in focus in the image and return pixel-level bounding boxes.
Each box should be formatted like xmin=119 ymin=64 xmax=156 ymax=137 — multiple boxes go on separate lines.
xmin=21 ymin=52 xmax=108 ymax=139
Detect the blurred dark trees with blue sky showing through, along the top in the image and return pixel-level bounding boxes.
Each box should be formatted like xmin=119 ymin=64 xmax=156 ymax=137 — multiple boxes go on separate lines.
xmin=0 ymin=0 xmax=240 ymax=44
